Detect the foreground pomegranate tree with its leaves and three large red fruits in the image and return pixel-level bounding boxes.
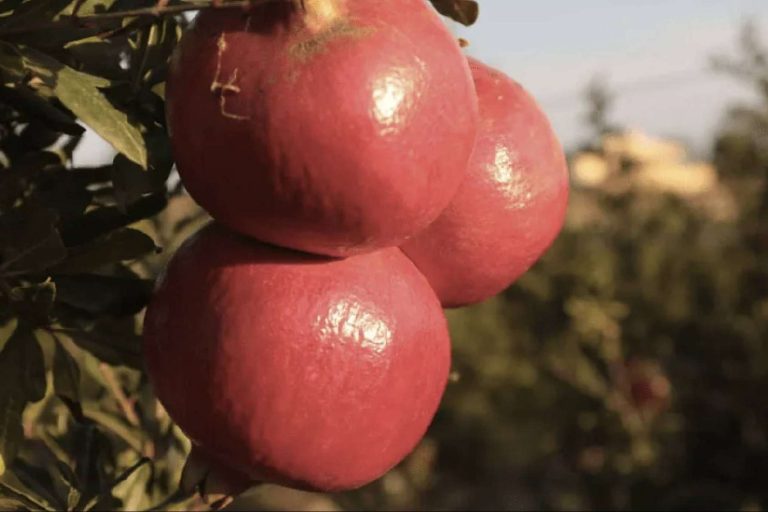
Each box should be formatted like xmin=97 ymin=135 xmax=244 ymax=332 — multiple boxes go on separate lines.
xmin=0 ymin=0 xmax=569 ymax=510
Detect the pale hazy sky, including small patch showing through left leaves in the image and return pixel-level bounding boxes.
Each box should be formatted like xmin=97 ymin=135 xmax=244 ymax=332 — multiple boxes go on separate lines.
xmin=75 ymin=0 xmax=768 ymax=165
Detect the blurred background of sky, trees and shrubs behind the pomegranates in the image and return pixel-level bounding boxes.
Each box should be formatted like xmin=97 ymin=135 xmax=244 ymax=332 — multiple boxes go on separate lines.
xmin=67 ymin=0 xmax=768 ymax=511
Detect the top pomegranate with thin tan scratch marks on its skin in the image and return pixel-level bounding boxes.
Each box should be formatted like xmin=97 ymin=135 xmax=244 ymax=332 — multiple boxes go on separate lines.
xmin=166 ymin=0 xmax=478 ymax=256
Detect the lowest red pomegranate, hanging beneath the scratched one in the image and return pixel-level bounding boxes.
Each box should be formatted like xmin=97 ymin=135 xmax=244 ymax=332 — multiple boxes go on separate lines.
xmin=143 ymin=224 xmax=450 ymax=491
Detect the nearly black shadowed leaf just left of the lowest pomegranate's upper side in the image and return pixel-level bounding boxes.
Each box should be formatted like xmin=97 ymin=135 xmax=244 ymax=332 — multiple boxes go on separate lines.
xmin=56 ymin=274 xmax=153 ymax=317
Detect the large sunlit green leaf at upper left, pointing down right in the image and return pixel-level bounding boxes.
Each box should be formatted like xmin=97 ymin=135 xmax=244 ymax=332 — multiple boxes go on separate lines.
xmin=16 ymin=48 xmax=147 ymax=168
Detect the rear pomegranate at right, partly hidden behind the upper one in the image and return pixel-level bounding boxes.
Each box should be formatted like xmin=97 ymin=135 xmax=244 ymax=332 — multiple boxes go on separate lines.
xmin=403 ymin=59 xmax=569 ymax=308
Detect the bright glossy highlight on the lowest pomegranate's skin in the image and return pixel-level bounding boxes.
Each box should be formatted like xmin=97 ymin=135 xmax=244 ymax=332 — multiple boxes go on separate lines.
xmin=316 ymin=297 xmax=393 ymax=355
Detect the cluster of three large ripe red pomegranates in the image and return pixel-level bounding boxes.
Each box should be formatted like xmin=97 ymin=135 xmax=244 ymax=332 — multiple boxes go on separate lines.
xmin=144 ymin=0 xmax=568 ymax=498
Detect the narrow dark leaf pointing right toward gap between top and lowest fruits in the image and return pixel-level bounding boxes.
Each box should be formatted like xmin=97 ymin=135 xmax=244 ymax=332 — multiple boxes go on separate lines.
xmin=52 ymin=228 xmax=157 ymax=274
